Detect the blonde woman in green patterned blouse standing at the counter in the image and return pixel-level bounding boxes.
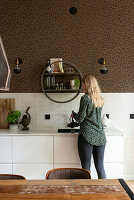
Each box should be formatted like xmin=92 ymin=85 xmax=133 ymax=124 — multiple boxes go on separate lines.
xmin=71 ymin=75 xmax=106 ymax=179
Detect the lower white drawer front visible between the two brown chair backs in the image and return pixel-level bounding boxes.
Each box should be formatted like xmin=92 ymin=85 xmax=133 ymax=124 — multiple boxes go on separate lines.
xmin=13 ymin=163 xmax=53 ymax=179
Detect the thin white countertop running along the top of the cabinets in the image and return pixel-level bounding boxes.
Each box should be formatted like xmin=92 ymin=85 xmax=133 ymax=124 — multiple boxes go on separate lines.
xmin=0 ymin=127 xmax=123 ymax=136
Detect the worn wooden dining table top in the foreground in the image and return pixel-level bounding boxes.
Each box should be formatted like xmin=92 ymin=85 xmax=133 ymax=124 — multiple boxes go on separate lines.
xmin=0 ymin=179 xmax=133 ymax=200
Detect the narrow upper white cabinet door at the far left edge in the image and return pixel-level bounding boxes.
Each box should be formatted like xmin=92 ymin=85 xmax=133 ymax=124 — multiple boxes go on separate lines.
xmin=0 ymin=136 xmax=12 ymax=163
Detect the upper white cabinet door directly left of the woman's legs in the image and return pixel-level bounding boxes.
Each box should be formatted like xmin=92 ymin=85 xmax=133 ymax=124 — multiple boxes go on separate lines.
xmin=54 ymin=135 xmax=80 ymax=164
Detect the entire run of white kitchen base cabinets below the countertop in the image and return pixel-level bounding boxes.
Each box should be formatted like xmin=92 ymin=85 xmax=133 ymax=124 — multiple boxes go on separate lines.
xmin=0 ymin=132 xmax=123 ymax=179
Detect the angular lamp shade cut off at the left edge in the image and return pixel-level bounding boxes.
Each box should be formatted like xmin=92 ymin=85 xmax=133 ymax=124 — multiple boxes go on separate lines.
xmin=0 ymin=36 xmax=11 ymax=91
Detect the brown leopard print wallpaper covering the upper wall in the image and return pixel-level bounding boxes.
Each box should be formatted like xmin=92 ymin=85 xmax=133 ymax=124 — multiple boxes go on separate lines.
xmin=0 ymin=0 xmax=134 ymax=93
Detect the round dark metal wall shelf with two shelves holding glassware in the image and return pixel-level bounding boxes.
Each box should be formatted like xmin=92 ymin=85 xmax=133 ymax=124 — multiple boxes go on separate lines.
xmin=41 ymin=61 xmax=82 ymax=103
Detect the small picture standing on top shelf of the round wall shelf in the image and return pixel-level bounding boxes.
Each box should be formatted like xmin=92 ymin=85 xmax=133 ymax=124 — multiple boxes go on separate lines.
xmin=50 ymin=58 xmax=64 ymax=73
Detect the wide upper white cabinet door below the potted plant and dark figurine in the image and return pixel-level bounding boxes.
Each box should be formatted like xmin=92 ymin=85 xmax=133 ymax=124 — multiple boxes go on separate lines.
xmin=13 ymin=136 xmax=53 ymax=163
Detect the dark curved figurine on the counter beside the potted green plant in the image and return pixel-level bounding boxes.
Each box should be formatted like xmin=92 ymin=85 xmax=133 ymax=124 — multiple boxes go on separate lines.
xmin=19 ymin=107 xmax=31 ymax=131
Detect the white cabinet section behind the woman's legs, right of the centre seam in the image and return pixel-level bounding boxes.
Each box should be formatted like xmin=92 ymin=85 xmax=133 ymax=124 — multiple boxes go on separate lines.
xmin=54 ymin=135 xmax=123 ymax=179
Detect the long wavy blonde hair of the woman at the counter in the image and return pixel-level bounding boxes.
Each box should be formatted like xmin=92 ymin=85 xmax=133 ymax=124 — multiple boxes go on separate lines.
xmin=82 ymin=74 xmax=104 ymax=108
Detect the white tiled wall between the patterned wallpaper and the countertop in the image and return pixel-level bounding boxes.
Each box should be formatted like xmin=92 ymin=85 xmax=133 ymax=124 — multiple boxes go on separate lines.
xmin=0 ymin=93 xmax=134 ymax=179
